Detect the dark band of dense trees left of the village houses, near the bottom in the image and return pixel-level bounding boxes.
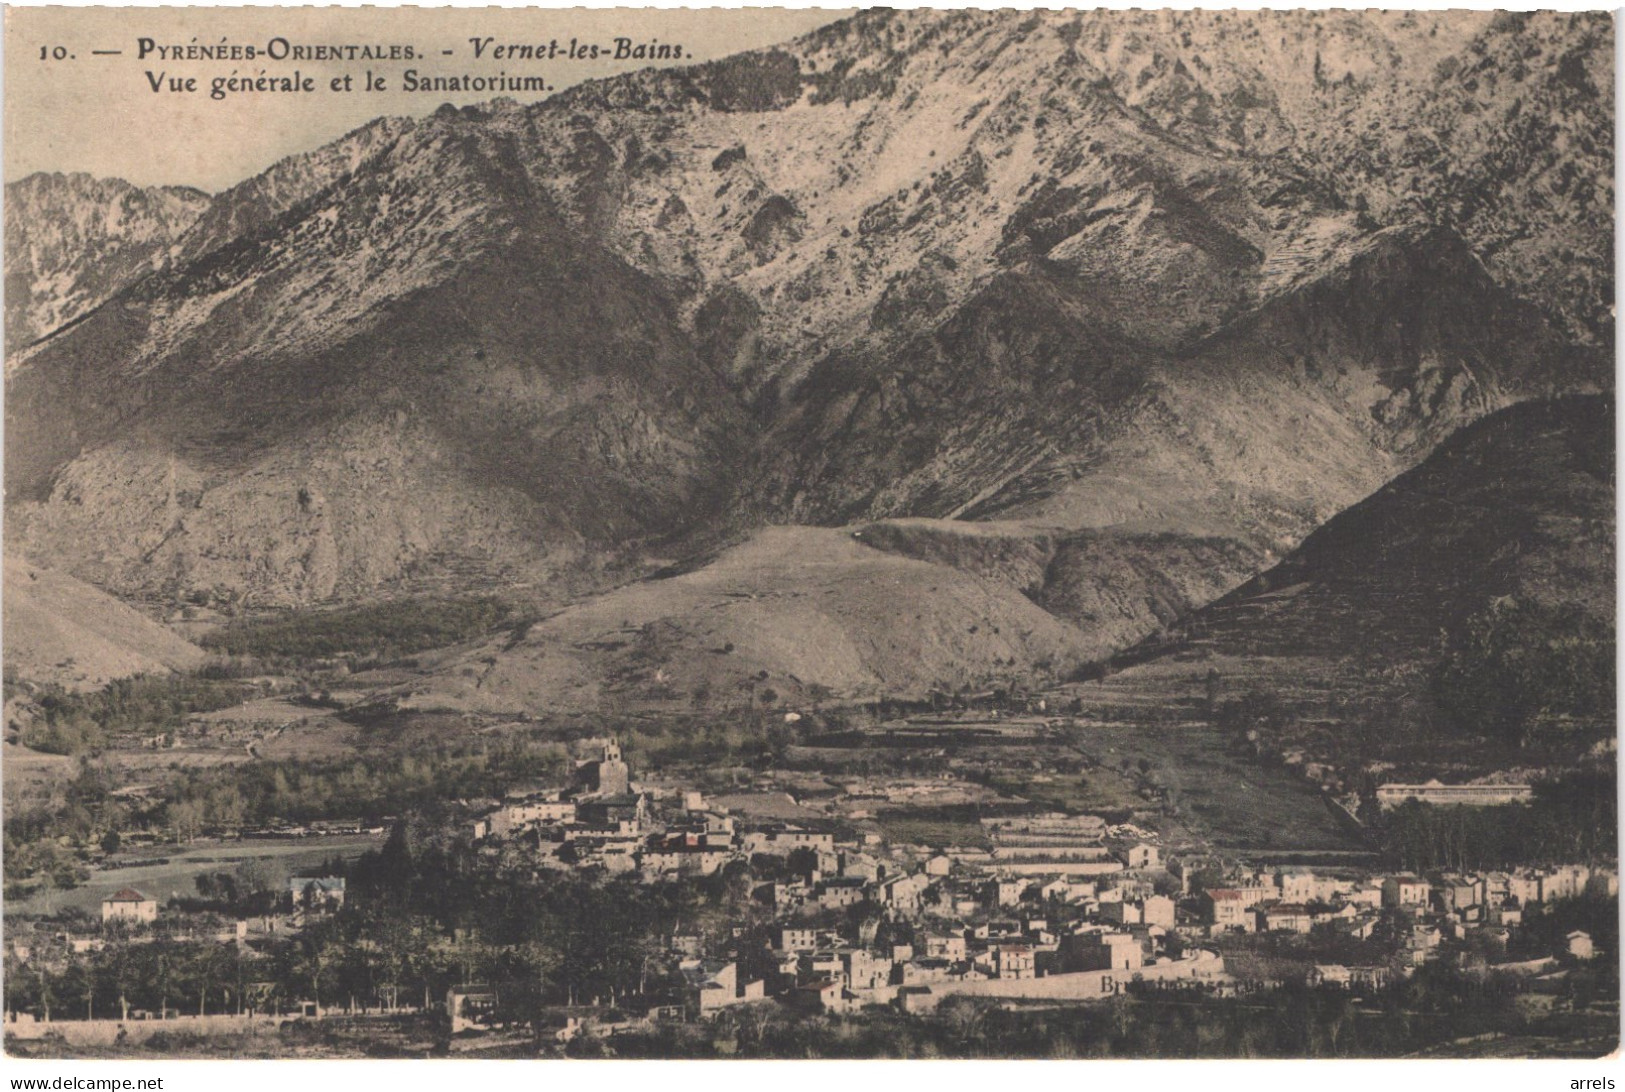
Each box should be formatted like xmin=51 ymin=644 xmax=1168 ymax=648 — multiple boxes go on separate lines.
xmin=7 ymin=852 xmax=692 ymax=1027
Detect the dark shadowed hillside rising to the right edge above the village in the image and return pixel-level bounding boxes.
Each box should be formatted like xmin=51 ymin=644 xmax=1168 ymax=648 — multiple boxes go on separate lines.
xmin=1190 ymin=397 xmax=1615 ymax=660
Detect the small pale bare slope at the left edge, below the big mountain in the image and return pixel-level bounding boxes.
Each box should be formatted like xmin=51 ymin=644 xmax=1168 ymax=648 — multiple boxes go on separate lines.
xmin=5 ymin=556 xmax=203 ymax=691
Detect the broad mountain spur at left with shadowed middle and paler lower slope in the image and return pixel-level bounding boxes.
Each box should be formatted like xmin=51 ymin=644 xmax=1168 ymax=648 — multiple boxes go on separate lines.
xmin=7 ymin=106 xmax=735 ymax=605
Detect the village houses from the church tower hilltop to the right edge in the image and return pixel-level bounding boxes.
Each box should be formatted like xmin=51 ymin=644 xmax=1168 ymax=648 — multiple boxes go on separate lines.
xmin=448 ymin=741 xmax=1617 ymax=1016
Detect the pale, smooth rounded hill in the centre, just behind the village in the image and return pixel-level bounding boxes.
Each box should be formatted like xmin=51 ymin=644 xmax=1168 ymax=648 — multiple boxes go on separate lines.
xmin=386 ymin=528 xmax=1084 ymax=713
